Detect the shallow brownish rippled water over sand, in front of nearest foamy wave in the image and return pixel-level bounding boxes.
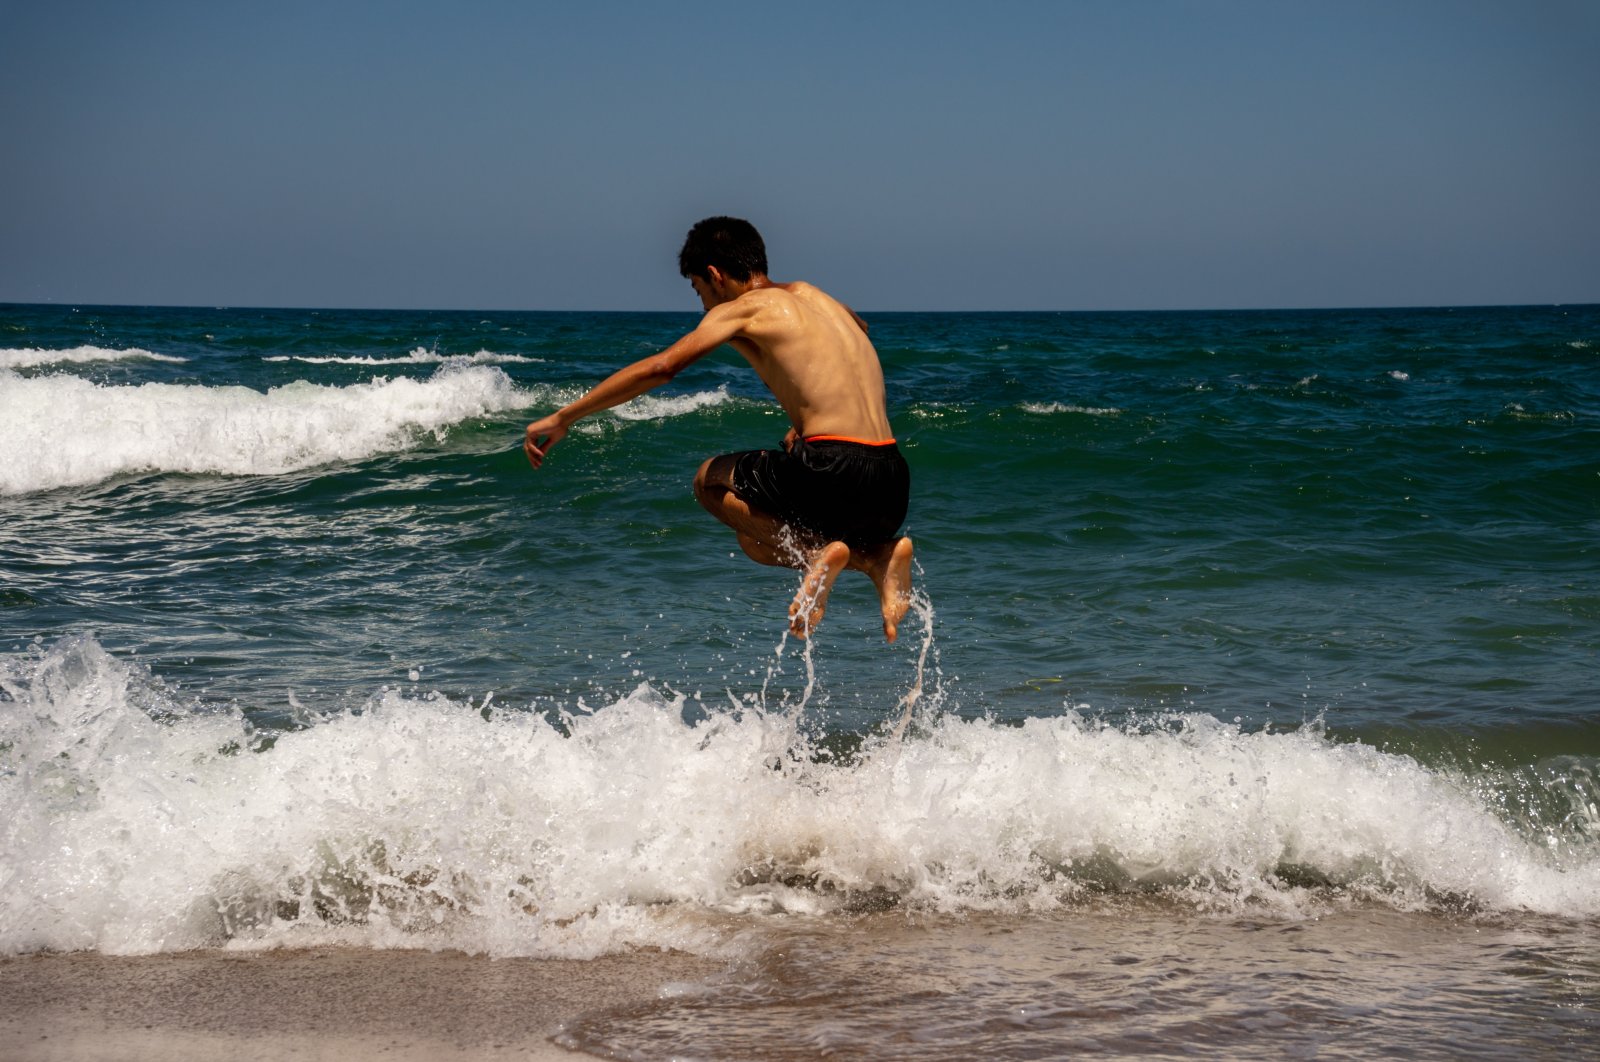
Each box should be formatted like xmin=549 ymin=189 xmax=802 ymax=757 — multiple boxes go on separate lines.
xmin=562 ymin=897 xmax=1600 ymax=1062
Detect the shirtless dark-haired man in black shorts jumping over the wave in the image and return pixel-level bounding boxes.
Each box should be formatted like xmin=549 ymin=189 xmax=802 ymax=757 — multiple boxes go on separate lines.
xmin=523 ymin=218 xmax=912 ymax=641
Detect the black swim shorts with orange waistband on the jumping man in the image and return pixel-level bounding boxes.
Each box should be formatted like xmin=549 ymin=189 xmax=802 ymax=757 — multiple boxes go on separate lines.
xmin=731 ymin=435 xmax=910 ymax=549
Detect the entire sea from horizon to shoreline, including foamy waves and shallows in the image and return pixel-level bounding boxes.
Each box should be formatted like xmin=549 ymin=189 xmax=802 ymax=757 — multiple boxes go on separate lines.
xmin=0 ymin=304 xmax=1600 ymax=1059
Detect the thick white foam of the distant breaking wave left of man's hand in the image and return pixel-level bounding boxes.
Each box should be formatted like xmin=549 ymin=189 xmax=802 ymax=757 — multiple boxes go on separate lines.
xmin=0 ymin=366 xmax=534 ymax=494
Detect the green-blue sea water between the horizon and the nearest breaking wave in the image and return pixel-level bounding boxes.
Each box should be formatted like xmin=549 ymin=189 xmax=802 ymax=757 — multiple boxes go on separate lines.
xmin=0 ymin=307 xmax=1600 ymax=738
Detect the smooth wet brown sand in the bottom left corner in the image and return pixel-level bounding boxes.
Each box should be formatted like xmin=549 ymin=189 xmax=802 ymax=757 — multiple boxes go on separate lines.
xmin=0 ymin=948 xmax=722 ymax=1062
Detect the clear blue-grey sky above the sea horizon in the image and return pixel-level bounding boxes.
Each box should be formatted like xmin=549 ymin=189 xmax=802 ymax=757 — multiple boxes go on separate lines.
xmin=0 ymin=0 xmax=1600 ymax=310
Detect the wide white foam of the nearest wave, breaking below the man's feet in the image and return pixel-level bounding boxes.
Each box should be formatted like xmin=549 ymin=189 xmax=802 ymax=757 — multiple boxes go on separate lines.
xmin=0 ymin=637 xmax=1600 ymax=956
